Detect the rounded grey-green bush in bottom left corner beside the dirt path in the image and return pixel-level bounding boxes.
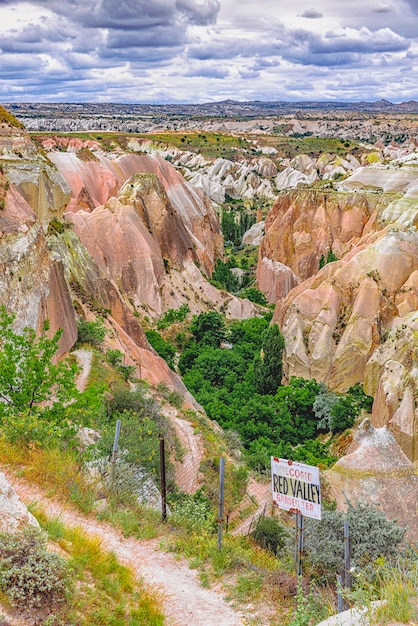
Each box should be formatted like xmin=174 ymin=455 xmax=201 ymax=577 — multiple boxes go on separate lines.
xmin=0 ymin=528 xmax=71 ymax=608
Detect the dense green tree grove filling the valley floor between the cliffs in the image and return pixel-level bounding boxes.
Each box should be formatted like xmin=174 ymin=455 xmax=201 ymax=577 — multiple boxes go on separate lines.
xmin=173 ymin=311 xmax=370 ymax=466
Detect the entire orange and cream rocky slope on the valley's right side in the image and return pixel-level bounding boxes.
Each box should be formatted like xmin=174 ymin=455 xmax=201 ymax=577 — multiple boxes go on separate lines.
xmin=258 ymin=153 xmax=418 ymax=461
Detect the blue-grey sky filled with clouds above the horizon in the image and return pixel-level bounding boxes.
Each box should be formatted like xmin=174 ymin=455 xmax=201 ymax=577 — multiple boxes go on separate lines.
xmin=0 ymin=0 xmax=418 ymax=104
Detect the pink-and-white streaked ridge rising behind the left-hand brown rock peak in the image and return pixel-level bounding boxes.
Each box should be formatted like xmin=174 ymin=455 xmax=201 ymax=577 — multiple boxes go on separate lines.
xmin=43 ymin=143 xmax=223 ymax=275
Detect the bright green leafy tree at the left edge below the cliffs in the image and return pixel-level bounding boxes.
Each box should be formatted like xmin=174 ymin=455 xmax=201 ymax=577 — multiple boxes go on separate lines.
xmin=0 ymin=306 xmax=78 ymax=441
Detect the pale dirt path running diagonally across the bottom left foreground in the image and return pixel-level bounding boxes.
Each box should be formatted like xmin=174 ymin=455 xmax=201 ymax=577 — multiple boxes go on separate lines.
xmin=2 ymin=469 xmax=244 ymax=626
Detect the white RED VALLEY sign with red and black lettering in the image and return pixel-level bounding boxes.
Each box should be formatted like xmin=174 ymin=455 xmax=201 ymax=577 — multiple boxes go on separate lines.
xmin=271 ymin=456 xmax=321 ymax=519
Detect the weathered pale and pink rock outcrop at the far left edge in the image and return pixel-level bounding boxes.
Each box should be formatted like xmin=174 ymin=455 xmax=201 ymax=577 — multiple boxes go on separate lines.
xmin=0 ymin=116 xmax=77 ymax=353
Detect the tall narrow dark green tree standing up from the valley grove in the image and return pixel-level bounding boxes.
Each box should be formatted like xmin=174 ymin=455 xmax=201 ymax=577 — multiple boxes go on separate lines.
xmin=254 ymin=324 xmax=284 ymax=395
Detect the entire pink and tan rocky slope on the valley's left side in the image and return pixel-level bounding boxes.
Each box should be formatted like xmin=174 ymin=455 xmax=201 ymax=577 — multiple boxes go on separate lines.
xmin=0 ymin=109 xmax=256 ymax=398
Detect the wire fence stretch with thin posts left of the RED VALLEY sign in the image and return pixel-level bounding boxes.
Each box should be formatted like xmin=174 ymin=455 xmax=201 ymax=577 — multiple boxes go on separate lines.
xmin=106 ymin=419 xmax=273 ymax=534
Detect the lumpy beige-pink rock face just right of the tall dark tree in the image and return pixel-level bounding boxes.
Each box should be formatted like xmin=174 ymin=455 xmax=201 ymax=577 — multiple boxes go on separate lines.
xmin=274 ymin=224 xmax=418 ymax=395
